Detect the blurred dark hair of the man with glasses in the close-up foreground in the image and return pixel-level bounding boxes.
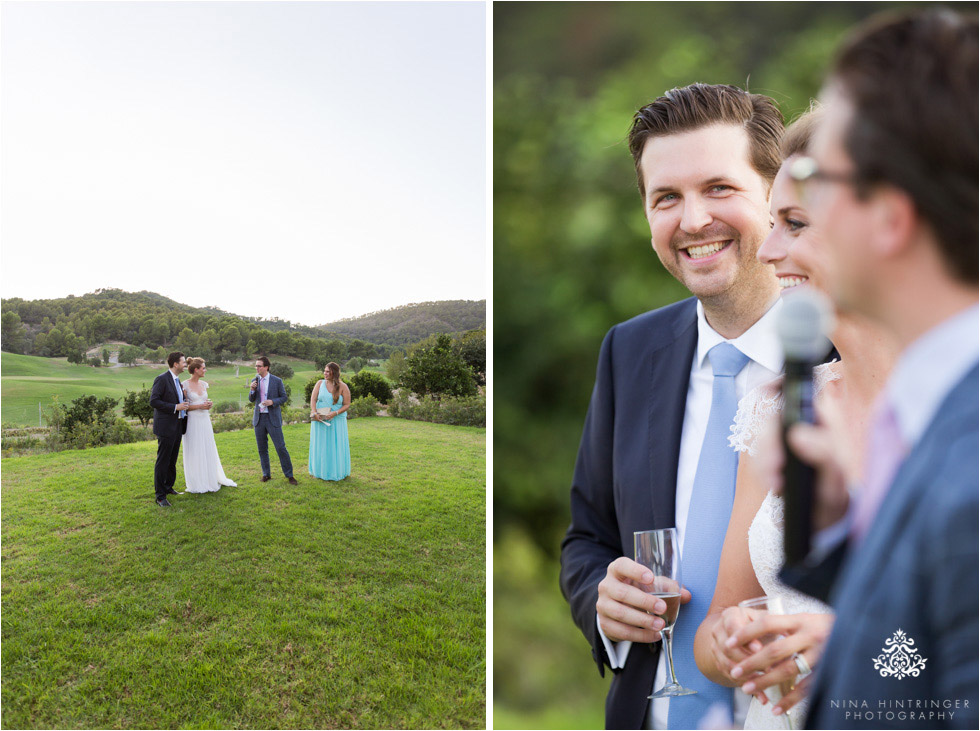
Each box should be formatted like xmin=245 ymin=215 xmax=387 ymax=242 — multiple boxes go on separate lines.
xmin=830 ymin=8 xmax=980 ymax=285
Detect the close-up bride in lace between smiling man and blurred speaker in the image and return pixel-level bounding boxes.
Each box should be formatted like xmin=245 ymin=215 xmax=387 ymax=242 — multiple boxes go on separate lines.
xmin=694 ymin=109 xmax=897 ymax=729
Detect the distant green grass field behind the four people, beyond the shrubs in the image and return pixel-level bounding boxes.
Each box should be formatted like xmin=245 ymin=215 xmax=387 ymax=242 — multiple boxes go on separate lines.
xmin=0 ymin=353 xmax=377 ymax=426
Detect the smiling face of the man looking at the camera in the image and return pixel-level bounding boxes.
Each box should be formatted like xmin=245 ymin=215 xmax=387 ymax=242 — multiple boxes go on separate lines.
xmin=640 ymin=124 xmax=776 ymax=307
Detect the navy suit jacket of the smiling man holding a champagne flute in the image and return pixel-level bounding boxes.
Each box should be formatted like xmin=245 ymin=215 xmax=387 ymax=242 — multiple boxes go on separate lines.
xmin=561 ymin=297 xmax=698 ymax=728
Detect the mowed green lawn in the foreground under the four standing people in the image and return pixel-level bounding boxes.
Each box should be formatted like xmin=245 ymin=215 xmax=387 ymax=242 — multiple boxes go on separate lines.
xmin=2 ymin=417 xmax=486 ymax=728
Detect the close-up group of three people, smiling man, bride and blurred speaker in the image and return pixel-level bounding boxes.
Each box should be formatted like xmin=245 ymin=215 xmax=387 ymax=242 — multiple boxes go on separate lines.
xmin=561 ymin=10 xmax=980 ymax=729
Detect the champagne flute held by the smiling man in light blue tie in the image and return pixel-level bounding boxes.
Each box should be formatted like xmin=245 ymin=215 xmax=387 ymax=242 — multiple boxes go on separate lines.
xmin=633 ymin=528 xmax=697 ymax=698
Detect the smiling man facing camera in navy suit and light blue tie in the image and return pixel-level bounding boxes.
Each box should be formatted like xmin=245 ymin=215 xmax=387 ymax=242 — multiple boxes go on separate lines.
xmin=561 ymin=84 xmax=783 ymax=728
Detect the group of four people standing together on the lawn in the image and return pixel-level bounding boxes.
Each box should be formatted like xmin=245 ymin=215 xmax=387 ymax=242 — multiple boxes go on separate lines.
xmin=150 ymin=352 xmax=351 ymax=507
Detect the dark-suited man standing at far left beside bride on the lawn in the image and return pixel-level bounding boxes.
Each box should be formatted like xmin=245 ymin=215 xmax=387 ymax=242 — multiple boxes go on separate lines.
xmin=150 ymin=352 xmax=188 ymax=508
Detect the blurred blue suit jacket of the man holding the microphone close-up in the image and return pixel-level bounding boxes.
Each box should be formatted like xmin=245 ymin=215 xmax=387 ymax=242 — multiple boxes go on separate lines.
xmin=783 ymin=366 xmax=980 ymax=729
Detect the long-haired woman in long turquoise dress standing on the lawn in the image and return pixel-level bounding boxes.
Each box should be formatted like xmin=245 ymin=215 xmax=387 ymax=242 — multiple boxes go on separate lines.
xmin=310 ymin=362 xmax=350 ymax=480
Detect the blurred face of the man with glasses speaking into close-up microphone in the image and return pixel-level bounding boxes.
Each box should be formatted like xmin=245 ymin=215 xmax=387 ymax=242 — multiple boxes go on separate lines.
xmin=802 ymin=87 xmax=876 ymax=312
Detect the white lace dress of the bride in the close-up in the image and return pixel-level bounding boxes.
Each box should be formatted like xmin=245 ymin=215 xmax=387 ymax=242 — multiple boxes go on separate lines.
xmin=729 ymin=363 xmax=840 ymax=729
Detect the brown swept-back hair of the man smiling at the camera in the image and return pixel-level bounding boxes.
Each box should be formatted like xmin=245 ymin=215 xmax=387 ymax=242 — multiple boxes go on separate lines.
xmin=629 ymin=84 xmax=783 ymax=195
